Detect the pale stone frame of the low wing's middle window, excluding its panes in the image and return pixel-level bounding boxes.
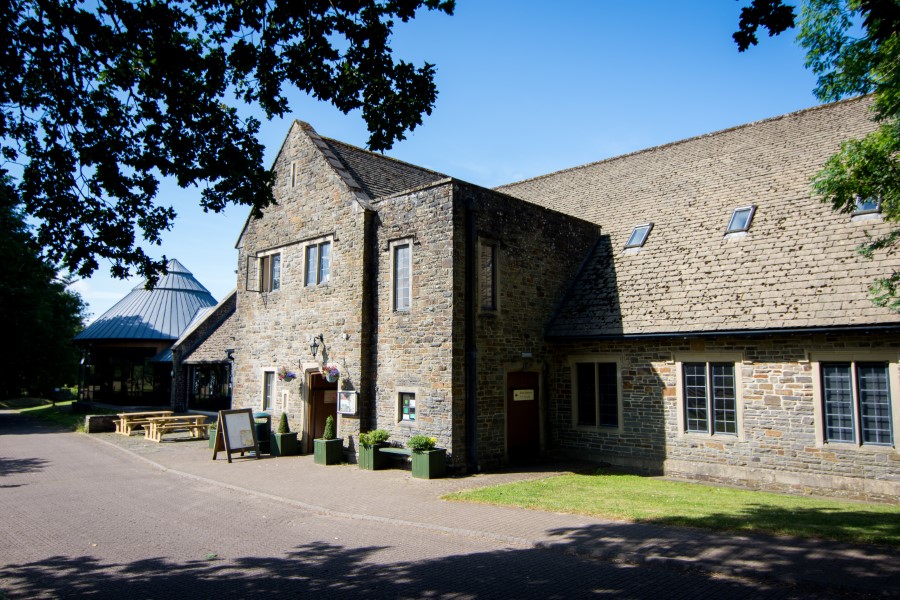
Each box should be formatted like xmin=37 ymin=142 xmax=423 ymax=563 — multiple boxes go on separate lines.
xmin=674 ymin=352 xmax=745 ymax=442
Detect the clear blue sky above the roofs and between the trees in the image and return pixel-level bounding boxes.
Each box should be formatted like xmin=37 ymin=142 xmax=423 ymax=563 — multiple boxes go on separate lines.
xmin=73 ymin=0 xmax=818 ymax=317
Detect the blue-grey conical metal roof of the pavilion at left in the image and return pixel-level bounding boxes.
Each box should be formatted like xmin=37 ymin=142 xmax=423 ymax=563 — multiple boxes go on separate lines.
xmin=75 ymin=259 xmax=216 ymax=341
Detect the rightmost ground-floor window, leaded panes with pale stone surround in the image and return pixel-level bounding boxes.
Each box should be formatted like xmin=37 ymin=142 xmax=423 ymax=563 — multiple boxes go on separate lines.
xmin=813 ymin=352 xmax=898 ymax=447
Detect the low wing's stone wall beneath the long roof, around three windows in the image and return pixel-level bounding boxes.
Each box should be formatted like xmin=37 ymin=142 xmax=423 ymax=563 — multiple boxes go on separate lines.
xmin=549 ymin=333 xmax=900 ymax=499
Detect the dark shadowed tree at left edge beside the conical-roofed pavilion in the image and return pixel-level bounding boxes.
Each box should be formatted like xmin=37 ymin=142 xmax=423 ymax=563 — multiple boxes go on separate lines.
xmin=0 ymin=180 xmax=85 ymax=398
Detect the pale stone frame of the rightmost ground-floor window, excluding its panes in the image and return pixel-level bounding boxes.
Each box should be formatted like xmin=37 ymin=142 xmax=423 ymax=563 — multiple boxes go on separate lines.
xmin=809 ymin=350 xmax=900 ymax=452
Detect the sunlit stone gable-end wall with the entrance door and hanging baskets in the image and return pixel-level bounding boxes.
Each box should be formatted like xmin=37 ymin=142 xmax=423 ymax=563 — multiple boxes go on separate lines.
xmin=232 ymin=122 xmax=370 ymax=447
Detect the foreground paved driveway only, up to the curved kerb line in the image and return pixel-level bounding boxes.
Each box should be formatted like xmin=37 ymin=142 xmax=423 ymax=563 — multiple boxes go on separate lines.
xmin=0 ymin=413 xmax=888 ymax=599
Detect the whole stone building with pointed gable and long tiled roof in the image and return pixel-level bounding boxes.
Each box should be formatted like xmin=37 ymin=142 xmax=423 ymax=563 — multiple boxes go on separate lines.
xmin=186 ymin=99 xmax=900 ymax=498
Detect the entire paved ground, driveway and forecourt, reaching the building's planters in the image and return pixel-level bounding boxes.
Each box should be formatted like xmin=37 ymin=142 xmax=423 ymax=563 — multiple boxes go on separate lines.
xmin=0 ymin=414 xmax=896 ymax=599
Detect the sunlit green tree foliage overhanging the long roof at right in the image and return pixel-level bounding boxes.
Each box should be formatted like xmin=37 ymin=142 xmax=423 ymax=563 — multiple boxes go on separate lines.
xmin=734 ymin=0 xmax=900 ymax=311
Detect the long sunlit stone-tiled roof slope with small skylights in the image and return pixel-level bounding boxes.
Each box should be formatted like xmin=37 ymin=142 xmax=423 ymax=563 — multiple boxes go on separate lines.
xmin=498 ymin=98 xmax=900 ymax=337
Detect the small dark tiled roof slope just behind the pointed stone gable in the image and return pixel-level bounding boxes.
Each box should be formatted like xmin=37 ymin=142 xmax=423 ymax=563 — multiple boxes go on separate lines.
xmin=322 ymin=138 xmax=446 ymax=199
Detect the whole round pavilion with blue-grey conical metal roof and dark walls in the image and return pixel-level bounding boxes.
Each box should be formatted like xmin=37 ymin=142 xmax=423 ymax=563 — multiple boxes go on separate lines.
xmin=75 ymin=259 xmax=216 ymax=406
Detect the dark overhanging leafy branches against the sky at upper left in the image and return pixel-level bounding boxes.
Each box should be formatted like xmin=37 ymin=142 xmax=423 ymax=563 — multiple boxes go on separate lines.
xmin=0 ymin=0 xmax=454 ymax=282
